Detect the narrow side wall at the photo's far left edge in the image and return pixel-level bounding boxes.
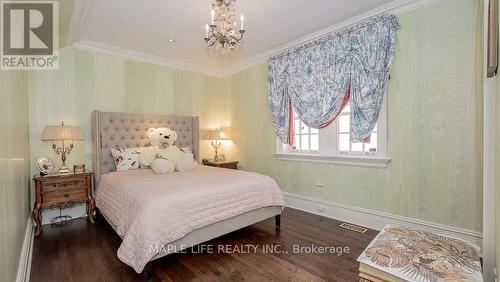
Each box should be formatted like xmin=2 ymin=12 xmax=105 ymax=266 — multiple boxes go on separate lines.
xmin=0 ymin=70 xmax=30 ymax=281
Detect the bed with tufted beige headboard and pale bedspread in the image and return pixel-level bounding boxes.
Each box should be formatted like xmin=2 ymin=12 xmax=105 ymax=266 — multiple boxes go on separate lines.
xmin=92 ymin=111 xmax=284 ymax=280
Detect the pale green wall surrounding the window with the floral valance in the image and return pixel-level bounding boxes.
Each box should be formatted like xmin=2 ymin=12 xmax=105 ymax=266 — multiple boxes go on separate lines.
xmin=184 ymin=0 xmax=482 ymax=231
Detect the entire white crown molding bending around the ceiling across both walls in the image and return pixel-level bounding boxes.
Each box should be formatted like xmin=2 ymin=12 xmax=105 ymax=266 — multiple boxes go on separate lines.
xmin=68 ymin=0 xmax=441 ymax=77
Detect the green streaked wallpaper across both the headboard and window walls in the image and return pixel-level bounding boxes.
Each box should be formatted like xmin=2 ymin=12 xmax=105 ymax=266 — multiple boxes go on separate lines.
xmin=29 ymin=0 xmax=482 ymax=231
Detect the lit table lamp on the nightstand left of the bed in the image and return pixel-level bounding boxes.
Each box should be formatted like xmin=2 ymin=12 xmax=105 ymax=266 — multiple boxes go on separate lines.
xmin=42 ymin=122 xmax=83 ymax=174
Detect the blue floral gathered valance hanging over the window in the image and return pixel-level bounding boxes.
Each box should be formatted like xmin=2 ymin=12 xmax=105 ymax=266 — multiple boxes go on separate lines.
xmin=268 ymin=15 xmax=399 ymax=144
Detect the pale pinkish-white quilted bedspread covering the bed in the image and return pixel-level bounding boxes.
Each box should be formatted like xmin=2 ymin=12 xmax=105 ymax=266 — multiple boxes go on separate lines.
xmin=96 ymin=165 xmax=284 ymax=273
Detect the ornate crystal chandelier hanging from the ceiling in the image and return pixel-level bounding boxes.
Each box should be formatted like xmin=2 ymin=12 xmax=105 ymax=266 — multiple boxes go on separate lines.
xmin=205 ymin=0 xmax=245 ymax=50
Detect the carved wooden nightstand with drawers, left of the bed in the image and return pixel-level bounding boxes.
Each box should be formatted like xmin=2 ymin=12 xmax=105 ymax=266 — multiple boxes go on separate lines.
xmin=33 ymin=172 xmax=95 ymax=236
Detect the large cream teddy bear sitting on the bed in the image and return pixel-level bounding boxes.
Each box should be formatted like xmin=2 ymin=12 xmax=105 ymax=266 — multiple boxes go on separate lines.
xmin=139 ymin=127 xmax=194 ymax=173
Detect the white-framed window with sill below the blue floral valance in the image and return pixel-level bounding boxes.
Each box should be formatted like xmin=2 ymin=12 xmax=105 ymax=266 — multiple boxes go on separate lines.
xmin=277 ymin=98 xmax=389 ymax=167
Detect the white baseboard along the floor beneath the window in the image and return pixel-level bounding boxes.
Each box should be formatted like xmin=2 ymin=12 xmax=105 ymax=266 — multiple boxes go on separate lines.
xmin=284 ymin=192 xmax=483 ymax=247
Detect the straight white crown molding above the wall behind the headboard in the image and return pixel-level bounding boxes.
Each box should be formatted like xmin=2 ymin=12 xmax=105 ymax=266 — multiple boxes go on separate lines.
xmin=73 ymin=39 xmax=221 ymax=77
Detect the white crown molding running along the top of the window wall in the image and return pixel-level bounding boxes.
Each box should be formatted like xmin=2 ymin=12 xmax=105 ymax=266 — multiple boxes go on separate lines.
xmin=220 ymin=0 xmax=440 ymax=77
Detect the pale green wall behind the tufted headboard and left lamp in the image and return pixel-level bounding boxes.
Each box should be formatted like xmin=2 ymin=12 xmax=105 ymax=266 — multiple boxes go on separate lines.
xmin=28 ymin=48 xmax=219 ymax=222
